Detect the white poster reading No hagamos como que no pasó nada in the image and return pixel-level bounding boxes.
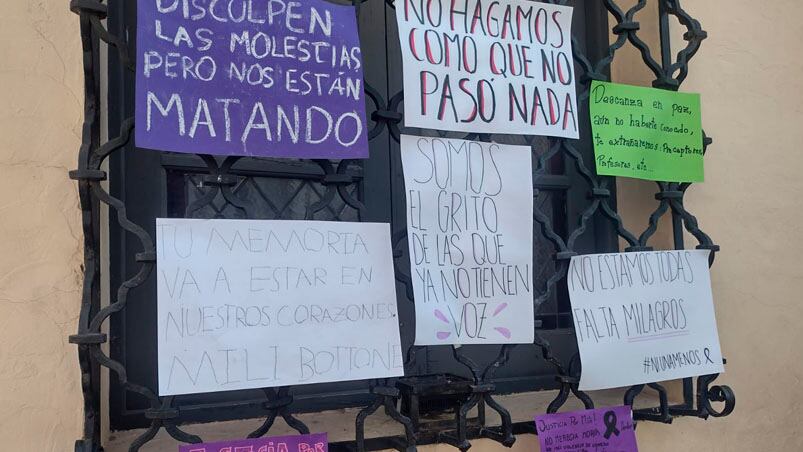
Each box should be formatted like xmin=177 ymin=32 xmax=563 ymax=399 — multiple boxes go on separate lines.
xmin=396 ymin=0 xmax=579 ymax=138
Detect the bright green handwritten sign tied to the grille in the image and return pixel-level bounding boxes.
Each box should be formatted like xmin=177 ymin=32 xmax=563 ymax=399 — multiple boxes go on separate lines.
xmin=590 ymin=81 xmax=703 ymax=182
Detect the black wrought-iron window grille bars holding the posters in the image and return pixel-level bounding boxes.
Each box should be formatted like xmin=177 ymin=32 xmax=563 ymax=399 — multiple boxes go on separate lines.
xmin=69 ymin=0 xmax=735 ymax=452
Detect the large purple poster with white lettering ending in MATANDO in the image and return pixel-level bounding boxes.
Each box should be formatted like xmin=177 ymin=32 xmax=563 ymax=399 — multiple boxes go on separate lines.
xmin=135 ymin=0 xmax=368 ymax=159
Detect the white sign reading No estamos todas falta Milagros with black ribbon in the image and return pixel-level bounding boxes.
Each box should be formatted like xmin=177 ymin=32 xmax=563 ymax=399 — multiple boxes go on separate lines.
xmin=567 ymin=250 xmax=724 ymax=390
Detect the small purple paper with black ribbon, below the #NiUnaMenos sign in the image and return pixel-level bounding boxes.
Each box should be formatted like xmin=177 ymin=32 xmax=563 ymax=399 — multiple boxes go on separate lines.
xmin=535 ymin=406 xmax=638 ymax=452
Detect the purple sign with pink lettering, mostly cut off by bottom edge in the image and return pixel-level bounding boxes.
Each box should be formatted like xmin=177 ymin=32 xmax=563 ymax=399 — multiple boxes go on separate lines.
xmin=178 ymin=433 xmax=329 ymax=452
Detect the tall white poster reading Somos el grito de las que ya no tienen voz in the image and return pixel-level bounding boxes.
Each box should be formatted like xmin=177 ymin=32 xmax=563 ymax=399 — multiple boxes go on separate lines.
xmin=401 ymin=135 xmax=534 ymax=345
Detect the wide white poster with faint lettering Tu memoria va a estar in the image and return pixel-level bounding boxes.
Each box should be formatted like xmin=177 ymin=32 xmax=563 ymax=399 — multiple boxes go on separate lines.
xmin=156 ymin=218 xmax=403 ymax=395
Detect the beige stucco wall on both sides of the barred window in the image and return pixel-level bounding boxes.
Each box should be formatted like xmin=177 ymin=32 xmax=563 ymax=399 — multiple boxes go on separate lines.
xmin=0 ymin=0 xmax=803 ymax=451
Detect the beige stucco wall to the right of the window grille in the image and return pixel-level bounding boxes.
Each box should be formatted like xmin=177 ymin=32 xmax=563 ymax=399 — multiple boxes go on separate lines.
xmin=617 ymin=0 xmax=803 ymax=452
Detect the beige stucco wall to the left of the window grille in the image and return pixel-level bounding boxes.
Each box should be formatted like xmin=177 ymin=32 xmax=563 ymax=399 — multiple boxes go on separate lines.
xmin=0 ymin=0 xmax=83 ymax=452
